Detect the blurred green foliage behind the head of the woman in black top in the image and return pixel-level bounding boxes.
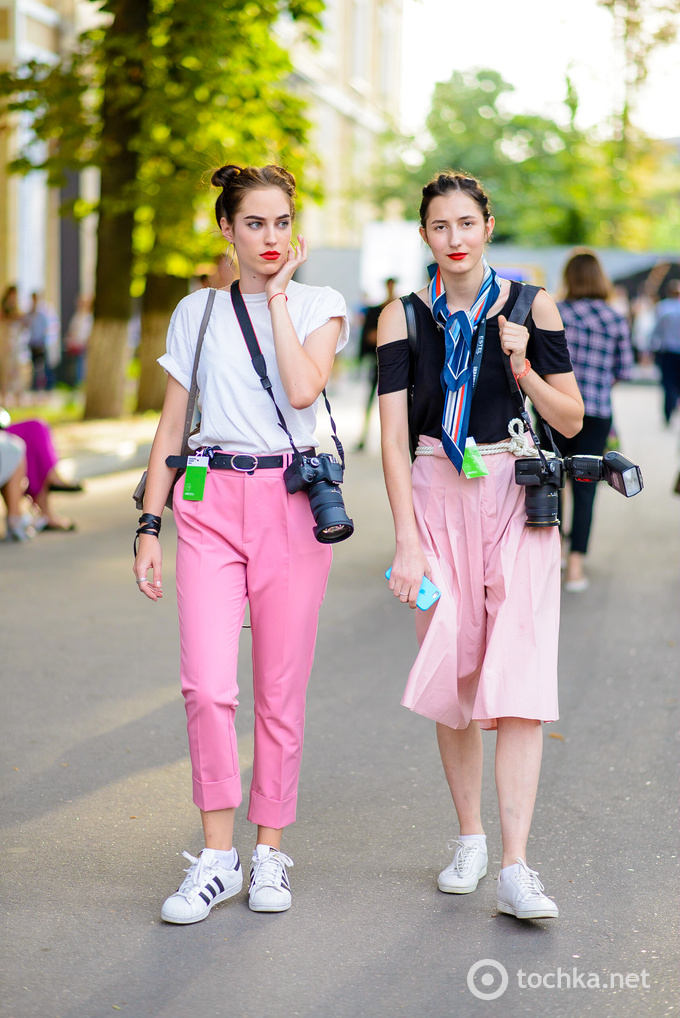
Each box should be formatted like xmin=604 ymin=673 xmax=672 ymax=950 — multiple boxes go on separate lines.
xmin=378 ymin=69 xmax=680 ymax=247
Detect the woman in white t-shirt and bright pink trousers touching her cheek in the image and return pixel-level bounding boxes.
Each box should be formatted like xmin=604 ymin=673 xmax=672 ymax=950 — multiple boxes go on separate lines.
xmin=134 ymin=166 xmax=349 ymax=923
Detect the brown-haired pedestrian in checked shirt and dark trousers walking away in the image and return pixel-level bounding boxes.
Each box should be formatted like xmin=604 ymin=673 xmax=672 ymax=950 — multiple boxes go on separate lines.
xmin=553 ymin=250 xmax=634 ymax=593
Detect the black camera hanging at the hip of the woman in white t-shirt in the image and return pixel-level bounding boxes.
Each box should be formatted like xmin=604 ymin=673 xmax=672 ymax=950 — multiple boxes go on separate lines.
xmin=283 ymin=452 xmax=354 ymax=545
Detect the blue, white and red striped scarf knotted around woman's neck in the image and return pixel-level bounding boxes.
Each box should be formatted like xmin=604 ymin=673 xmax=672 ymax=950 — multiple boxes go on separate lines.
xmin=430 ymin=258 xmax=501 ymax=473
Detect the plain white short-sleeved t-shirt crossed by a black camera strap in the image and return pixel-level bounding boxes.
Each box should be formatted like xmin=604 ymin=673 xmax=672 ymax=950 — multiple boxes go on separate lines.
xmin=158 ymin=281 xmax=349 ymax=455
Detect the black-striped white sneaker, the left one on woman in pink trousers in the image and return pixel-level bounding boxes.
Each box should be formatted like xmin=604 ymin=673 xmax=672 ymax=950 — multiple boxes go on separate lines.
xmin=161 ymin=848 xmax=243 ymax=923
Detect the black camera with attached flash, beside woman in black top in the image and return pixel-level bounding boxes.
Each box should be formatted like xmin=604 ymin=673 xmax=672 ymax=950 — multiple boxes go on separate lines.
xmin=515 ymin=450 xmax=643 ymax=526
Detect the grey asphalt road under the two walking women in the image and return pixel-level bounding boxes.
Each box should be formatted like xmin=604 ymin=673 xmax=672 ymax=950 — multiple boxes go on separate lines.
xmin=0 ymin=387 xmax=678 ymax=1018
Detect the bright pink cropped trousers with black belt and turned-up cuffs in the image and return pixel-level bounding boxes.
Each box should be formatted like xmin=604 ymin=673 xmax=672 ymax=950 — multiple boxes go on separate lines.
xmin=173 ymin=469 xmax=332 ymax=828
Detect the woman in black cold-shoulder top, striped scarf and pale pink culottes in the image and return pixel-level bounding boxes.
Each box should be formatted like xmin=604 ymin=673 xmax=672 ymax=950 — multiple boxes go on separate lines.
xmin=378 ymin=173 xmax=583 ymax=918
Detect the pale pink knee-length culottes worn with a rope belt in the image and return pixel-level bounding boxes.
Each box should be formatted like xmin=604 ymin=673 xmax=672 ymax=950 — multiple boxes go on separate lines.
xmin=402 ymin=438 xmax=560 ymax=728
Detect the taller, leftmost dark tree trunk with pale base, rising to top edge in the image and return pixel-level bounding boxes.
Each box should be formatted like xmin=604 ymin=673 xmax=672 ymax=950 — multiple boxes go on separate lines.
xmin=84 ymin=0 xmax=151 ymax=419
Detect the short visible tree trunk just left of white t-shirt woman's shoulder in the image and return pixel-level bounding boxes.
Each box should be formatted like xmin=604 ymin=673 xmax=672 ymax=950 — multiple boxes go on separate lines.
xmin=136 ymin=275 xmax=188 ymax=413
